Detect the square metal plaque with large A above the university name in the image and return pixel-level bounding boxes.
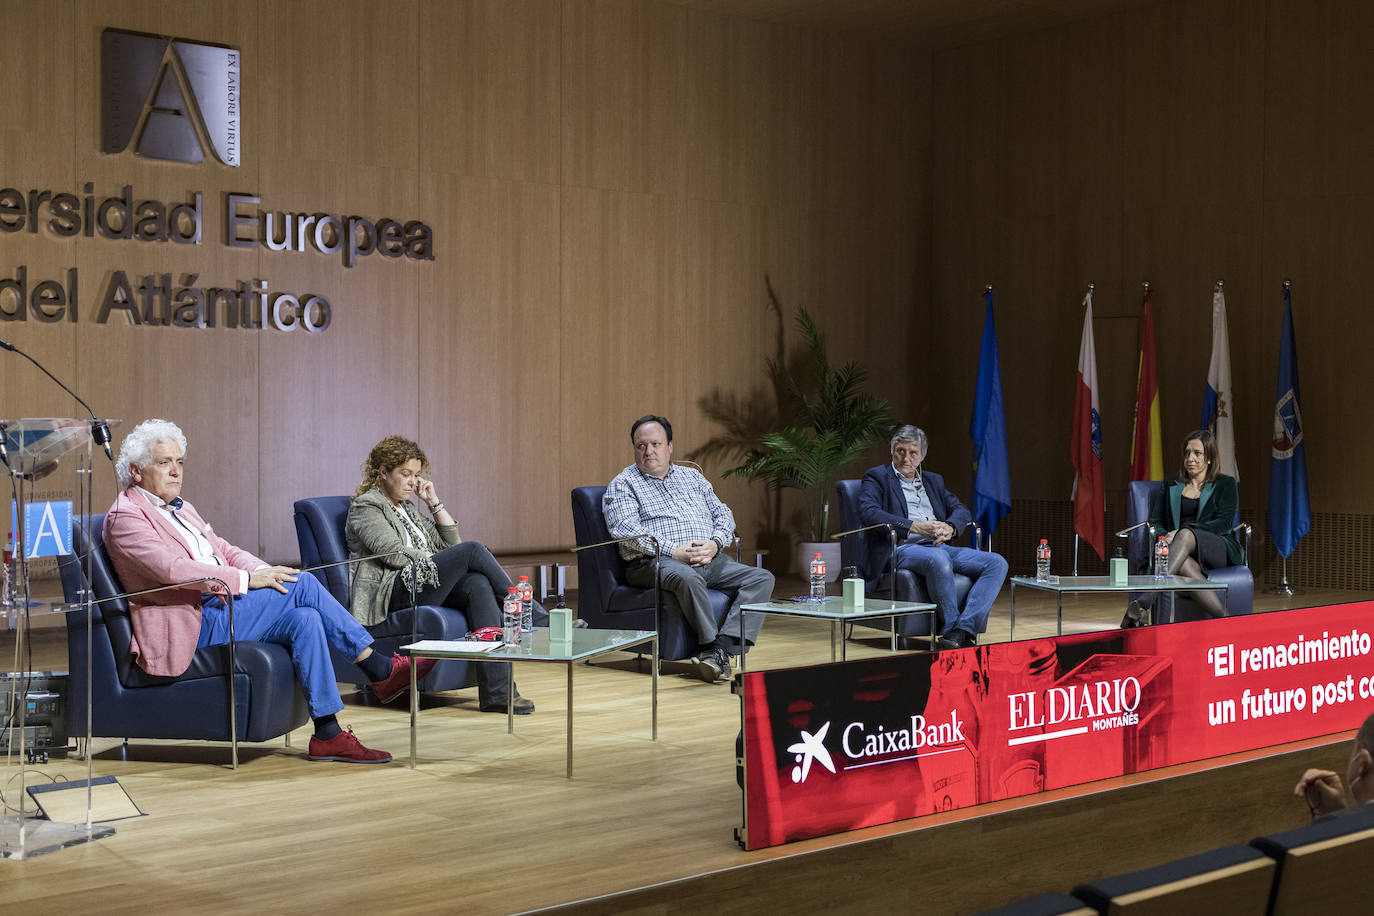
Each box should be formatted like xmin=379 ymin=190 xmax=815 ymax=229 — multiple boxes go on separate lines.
xmin=100 ymin=29 xmax=243 ymax=168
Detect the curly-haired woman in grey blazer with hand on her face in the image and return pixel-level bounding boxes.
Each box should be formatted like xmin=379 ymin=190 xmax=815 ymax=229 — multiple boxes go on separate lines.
xmin=345 ymin=435 xmax=534 ymax=715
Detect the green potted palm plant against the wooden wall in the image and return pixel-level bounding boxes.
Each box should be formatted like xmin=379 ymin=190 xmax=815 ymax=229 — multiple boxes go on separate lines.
xmin=725 ymin=307 xmax=892 ymax=581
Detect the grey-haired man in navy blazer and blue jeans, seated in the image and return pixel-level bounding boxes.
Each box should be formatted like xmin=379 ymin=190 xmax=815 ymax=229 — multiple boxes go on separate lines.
xmin=859 ymin=426 xmax=1007 ymax=648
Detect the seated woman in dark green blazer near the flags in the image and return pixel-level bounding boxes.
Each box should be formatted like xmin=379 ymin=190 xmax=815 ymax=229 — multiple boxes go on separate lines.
xmin=1150 ymin=430 xmax=1245 ymax=617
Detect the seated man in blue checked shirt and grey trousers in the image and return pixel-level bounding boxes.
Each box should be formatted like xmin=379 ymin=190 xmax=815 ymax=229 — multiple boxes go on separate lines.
xmin=605 ymin=415 xmax=774 ymax=684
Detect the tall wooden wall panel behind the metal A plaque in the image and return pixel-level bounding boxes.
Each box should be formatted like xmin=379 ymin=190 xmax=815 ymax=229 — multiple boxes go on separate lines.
xmin=69 ymin=3 xmax=264 ymax=549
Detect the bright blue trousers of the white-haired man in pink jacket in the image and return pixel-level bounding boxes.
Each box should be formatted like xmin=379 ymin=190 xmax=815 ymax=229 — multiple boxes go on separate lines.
xmin=196 ymin=573 xmax=372 ymax=718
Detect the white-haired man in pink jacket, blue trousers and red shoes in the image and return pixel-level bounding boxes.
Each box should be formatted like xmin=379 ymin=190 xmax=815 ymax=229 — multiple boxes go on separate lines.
xmin=104 ymin=420 xmax=425 ymax=764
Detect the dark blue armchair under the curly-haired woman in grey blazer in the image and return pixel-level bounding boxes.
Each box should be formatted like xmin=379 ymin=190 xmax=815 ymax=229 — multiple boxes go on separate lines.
xmin=294 ymin=496 xmax=477 ymax=694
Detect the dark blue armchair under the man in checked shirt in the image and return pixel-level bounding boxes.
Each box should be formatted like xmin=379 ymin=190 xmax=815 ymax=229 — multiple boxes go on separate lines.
xmin=573 ymin=486 xmax=735 ymax=661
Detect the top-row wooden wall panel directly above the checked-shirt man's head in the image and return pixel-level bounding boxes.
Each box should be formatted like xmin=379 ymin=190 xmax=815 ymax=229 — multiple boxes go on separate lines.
xmin=562 ymin=0 xmax=687 ymax=192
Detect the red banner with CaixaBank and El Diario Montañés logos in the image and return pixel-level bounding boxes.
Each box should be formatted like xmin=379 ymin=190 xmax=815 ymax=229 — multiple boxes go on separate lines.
xmin=742 ymin=602 xmax=1374 ymax=849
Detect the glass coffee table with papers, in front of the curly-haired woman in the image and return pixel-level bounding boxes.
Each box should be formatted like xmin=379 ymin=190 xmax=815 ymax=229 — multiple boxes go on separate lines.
xmin=401 ymin=626 xmax=658 ymax=779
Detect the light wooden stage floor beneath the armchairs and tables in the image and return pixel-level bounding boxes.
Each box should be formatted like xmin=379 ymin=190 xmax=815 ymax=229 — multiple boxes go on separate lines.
xmin=0 ymin=588 xmax=1374 ymax=915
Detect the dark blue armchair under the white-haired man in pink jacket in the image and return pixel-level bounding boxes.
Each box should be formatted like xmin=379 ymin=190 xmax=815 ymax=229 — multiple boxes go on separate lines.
xmin=58 ymin=515 xmax=309 ymax=765
